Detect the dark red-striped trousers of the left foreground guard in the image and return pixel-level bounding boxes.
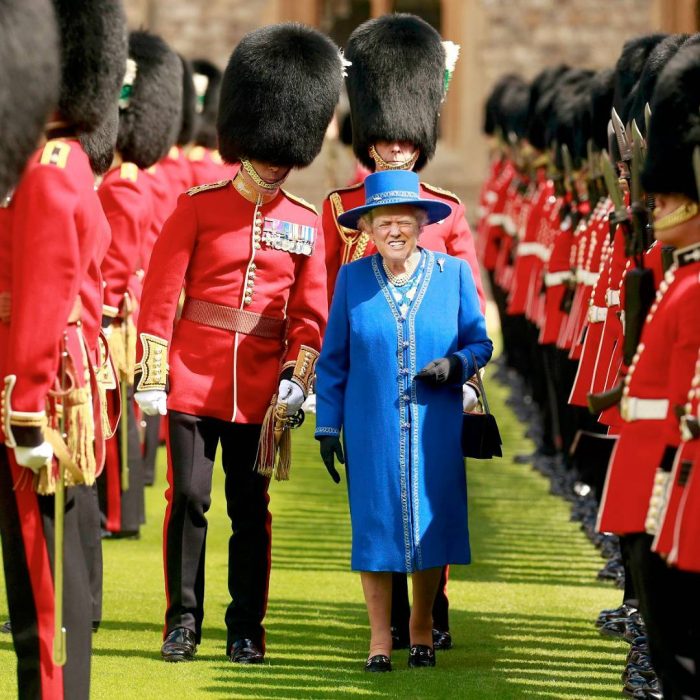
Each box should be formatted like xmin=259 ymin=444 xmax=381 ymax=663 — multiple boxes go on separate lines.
xmin=0 ymin=445 xmax=92 ymax=700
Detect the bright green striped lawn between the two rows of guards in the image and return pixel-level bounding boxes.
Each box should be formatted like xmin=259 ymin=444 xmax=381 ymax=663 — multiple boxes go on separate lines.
xmin=0 ymin=366 xmax=626 ymax=700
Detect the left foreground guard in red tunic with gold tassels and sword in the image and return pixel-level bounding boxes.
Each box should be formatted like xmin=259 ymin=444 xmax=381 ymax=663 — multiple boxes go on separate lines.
xmin=0 ymin=0 xmax=126 ymax=699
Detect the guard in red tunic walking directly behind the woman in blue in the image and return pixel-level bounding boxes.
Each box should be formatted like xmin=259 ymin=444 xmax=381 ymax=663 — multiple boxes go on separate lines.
xmin=322 ymin=14 xmax=486 ymax=648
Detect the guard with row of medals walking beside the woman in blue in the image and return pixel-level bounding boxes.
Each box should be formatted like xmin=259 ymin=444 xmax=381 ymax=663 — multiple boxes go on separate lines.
xmin=136 ymin=24 xmax=342 ymax=663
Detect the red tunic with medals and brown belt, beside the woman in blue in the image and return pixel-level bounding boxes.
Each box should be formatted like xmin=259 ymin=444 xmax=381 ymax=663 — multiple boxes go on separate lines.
xmin=137 ymin=181 xmax=328 ymax=423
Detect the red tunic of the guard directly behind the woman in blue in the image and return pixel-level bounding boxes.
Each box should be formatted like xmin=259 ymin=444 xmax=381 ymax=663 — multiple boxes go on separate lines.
xmin=322 ymin=183 xmax=486 ymax=311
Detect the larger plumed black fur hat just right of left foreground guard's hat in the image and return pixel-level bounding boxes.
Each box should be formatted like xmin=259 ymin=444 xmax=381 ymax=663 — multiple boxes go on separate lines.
xmin=117 ymin=31 xmax=182 ymax=168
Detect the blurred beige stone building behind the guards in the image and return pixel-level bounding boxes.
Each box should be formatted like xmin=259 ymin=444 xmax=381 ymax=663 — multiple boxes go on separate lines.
xmin=126 ymin=0 xmax=700 ymax=216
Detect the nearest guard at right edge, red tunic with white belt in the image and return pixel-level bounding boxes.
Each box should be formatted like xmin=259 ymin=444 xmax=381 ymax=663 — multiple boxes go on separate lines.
xmin=598 ymin=44 xmax=700 ymax=698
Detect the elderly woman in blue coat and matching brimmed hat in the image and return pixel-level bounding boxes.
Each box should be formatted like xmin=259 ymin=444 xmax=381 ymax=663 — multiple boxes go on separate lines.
xmin=316 ymin=171 xmax=493 ymax=671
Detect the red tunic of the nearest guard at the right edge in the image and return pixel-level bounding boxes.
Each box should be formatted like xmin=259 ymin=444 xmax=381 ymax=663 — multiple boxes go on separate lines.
xmin=598 ymin=245 xmax=700 ymax=534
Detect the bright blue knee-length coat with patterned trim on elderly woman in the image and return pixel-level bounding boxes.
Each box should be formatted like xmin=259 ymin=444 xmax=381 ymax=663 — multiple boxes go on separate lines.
xmin=316 ymin=251 xmax=493 ymax=572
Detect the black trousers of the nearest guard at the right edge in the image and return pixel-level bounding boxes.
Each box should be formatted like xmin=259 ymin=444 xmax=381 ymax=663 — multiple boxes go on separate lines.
xmin=627 ymin=533 xmax=700 ymax=700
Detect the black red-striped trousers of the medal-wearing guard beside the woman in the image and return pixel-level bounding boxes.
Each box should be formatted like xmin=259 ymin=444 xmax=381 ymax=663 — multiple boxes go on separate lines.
xmin=165 ymin=411 xmax=272 ymax=652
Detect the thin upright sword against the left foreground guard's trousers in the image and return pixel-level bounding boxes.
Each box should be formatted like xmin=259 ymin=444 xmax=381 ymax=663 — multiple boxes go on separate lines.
xmin=53 ymin=333 xmax=68 ymax=666
